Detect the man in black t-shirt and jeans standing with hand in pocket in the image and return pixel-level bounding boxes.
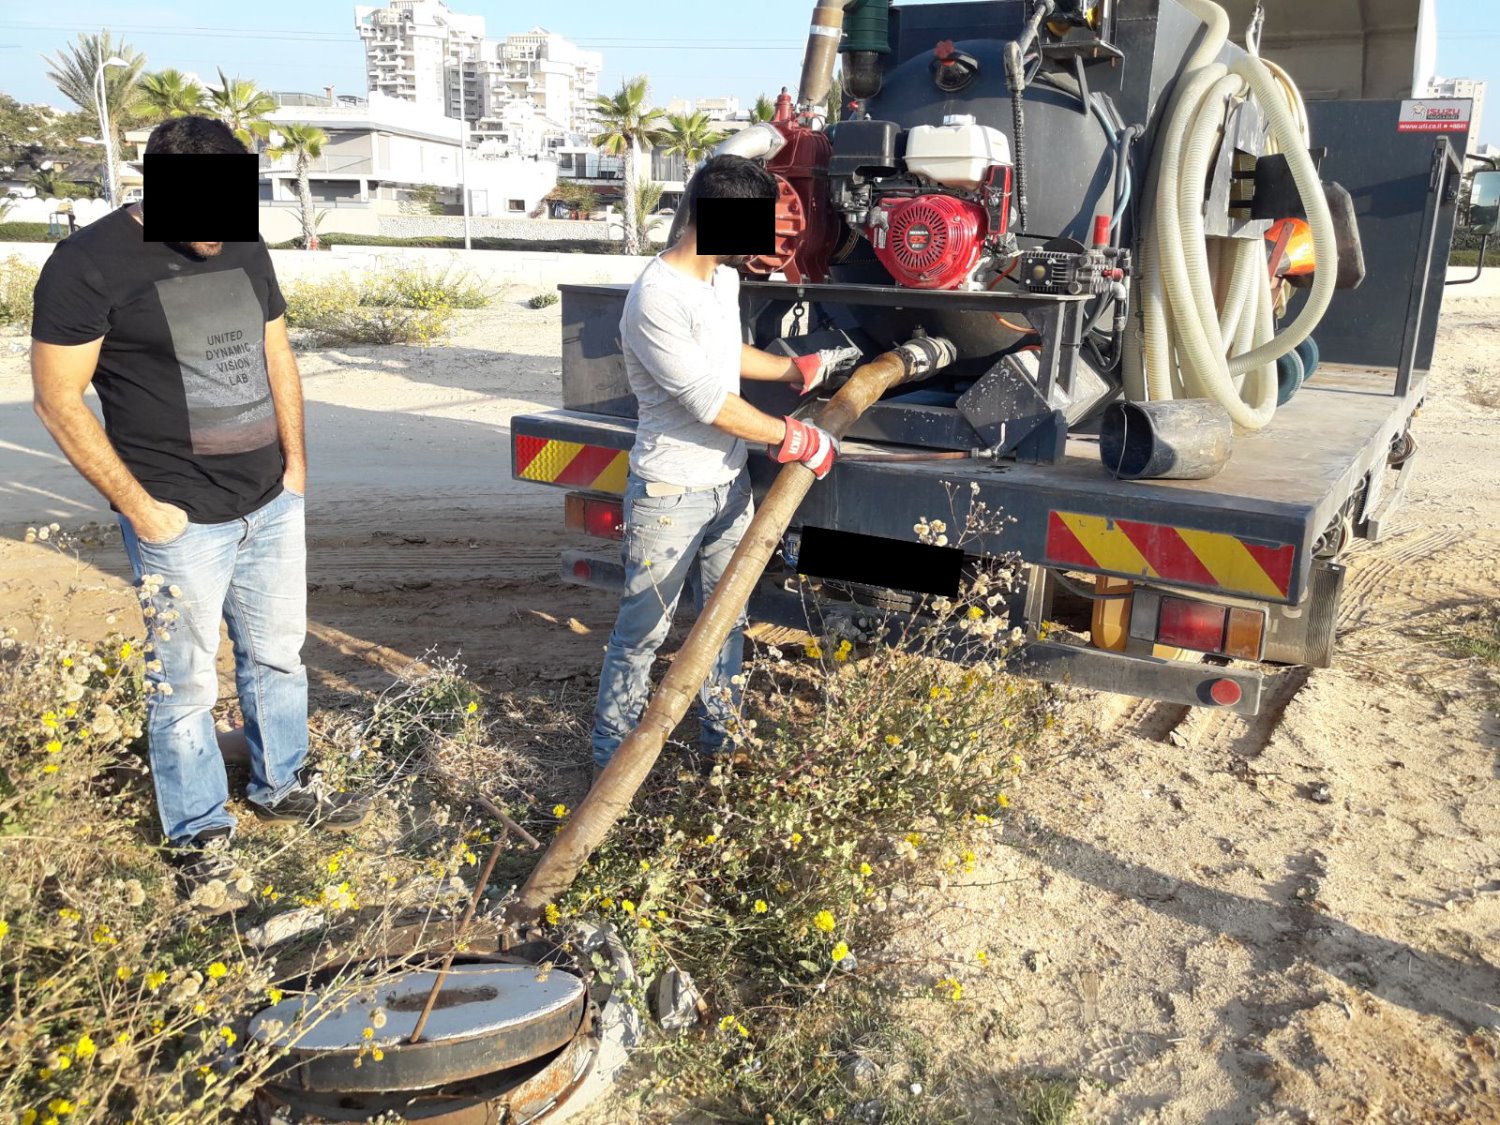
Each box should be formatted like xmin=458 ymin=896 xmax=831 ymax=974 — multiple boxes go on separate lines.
xmin=32 ymin=117 xmax=368 ymax=911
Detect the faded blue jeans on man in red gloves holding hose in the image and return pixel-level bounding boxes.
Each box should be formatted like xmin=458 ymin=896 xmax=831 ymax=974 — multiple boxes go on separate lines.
xmin=594 ymin=473 xmax=755 ymax=767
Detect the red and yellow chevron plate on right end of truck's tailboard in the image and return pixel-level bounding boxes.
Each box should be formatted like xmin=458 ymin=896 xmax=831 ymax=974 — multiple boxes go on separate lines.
xmin=1046 ymin=512 xmax=1296 ymax=599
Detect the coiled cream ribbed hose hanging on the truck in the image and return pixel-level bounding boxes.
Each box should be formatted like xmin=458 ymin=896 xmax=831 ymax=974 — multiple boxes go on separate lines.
xmin=1125 ymin=0 xmax=1338 ymax=431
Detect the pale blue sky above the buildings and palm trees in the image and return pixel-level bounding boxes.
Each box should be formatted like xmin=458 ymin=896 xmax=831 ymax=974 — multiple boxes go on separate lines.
xmin=0 ymin=0 xmax=1500 ymax=144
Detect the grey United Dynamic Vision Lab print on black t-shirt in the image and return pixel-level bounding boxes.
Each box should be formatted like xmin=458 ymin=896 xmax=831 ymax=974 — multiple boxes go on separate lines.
xmin=156 ymin=270 xmax=276 ymax=456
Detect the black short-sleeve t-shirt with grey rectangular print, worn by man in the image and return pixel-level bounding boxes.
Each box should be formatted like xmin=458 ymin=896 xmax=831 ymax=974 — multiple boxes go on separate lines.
xmin=32 ymin=207 xmax=287 ymax=524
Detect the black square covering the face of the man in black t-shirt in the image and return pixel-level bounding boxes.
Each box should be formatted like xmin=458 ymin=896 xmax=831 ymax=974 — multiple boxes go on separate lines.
xmin=141 ymin=153 xmax=261 ymax=243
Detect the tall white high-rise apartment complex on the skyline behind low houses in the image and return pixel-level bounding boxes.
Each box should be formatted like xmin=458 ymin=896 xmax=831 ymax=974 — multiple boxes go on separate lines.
xmin=354 ymin=0 xmax=605 ymax=156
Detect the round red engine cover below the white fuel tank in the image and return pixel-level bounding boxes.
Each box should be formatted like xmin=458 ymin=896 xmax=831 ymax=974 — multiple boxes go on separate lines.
xmin=870 ymin=195 xmax=986 ymax=290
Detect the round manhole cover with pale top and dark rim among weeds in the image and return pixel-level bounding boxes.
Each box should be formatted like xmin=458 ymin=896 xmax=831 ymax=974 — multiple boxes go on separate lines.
xmin=249 ymin=962 xmax=588 ymax=1092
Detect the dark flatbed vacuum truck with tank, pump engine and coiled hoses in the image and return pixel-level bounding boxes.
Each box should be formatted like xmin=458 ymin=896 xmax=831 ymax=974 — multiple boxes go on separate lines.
xmin=512 ymin=0 xmax=1497 ymax=714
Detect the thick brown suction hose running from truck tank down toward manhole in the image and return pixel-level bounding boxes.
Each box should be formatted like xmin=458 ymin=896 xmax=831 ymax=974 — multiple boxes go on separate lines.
xmin=506 ymin=336 xmax=957 ymax=924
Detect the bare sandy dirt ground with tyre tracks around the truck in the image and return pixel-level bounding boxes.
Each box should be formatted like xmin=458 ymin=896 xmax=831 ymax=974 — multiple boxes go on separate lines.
xmin=0 ymin=291 xmax=1500 ymax=1122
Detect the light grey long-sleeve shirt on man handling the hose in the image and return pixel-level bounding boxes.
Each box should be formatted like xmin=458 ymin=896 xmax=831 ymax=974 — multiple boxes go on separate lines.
xmin=620 ymin=258 xmax=746 ymax=488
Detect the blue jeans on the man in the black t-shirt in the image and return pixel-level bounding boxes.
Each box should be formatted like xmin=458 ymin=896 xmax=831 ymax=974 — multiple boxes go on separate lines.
xmin=120 ymin=491 xmax=308 ymax=843
